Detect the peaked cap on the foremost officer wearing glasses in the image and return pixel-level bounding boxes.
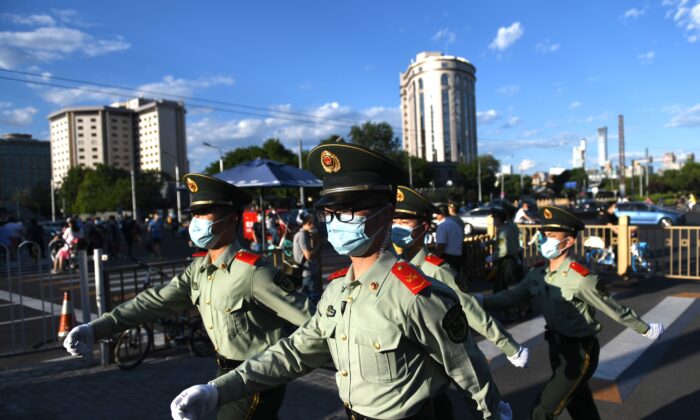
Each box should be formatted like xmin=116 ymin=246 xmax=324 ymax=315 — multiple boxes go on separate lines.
xmin=306 ymin=143 xmax=408 ymax=209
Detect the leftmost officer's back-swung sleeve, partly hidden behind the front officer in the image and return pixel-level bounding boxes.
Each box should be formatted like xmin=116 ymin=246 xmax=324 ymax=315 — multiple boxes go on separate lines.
xmin=251 ymin=266 xmax=315 ymax=326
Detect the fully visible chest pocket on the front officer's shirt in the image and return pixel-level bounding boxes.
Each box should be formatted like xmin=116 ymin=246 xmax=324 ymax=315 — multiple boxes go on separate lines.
xmin=355 ymin=329 xmax=408 ymax=382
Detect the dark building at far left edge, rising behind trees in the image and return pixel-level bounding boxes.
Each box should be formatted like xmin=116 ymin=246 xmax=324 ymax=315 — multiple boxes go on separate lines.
xmin=0 ymin=133 xmax=51 ymax=201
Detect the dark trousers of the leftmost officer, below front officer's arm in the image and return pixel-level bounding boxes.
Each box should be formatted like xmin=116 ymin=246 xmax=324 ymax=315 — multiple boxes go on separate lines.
xmin=216 ymin=368 xmax=286 ymax=420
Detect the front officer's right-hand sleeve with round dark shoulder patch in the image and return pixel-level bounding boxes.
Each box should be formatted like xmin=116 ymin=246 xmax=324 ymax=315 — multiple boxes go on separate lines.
xmin=408 ymin=283 xmax=501 ymax=418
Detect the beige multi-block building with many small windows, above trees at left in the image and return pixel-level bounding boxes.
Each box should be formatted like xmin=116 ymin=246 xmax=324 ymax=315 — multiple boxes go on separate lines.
xmin=48 ymin=98 xmax=188 ymax=186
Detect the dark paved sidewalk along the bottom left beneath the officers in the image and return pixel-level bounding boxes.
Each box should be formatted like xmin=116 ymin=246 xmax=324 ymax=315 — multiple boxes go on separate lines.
xmin=0 ymin=354 xmax=346 ymax=420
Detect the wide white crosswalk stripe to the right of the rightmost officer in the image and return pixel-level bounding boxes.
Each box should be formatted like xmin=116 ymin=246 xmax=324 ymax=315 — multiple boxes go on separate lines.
xmin=590 ymin=296 xmax=700 ymax=403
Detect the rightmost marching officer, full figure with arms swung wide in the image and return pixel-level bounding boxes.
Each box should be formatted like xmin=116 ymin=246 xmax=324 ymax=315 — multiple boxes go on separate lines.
xmin=476 ymin=207 xmax=663 ymax=420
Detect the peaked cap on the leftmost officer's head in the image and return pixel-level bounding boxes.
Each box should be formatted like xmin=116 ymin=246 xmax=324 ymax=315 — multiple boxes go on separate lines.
xmin=182 ymin=174 xmax=253 ymax=211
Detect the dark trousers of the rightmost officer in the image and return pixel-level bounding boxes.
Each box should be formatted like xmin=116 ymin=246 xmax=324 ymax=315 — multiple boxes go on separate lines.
xmin=532 ymin=330 xmax=600 ymax=420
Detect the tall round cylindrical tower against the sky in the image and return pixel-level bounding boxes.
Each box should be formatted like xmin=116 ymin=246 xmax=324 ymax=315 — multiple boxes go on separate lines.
xmin=400 ymin=52 xmax=477 ymax=162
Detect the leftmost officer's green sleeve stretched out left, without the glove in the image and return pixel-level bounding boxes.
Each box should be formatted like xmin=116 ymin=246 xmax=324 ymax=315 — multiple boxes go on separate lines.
xmin=90 ymin=264 xmax=193 ymax=340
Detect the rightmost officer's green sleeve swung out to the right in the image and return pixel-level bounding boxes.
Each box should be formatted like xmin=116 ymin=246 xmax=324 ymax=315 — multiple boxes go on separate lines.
xmin=578 ymin=274 xmax=649 ymax=334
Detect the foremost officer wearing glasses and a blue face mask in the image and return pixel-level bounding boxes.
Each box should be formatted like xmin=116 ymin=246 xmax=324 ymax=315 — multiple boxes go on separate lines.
xmin=171 ymin=144 xmax=511 ymax=420
